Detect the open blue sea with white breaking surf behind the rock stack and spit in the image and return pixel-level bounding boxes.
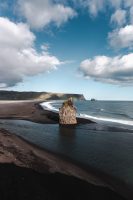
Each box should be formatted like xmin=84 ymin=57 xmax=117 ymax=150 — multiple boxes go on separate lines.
xmin=41 ymin=101 xmax=133 ymax=130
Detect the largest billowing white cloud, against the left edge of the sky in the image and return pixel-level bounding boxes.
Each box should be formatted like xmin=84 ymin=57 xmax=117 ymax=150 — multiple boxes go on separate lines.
xmin=0 ymin=17 xmax=61 ymax=87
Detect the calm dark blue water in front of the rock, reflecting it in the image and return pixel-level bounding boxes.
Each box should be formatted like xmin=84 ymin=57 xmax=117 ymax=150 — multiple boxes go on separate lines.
xmin=0 ymin=120 xmax=133 ymax=198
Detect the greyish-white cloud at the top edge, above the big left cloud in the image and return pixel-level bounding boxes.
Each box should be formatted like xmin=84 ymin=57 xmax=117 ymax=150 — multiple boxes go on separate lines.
xmin=18 ymin=0 xmax=76 ymax=29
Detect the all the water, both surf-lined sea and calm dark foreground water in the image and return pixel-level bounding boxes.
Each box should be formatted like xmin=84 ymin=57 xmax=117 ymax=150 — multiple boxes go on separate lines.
xmin=0 ymin=101 xmax=133 ymax=199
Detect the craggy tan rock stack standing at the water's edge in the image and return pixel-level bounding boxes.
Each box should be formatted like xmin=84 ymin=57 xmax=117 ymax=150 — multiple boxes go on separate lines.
xmin=59 ymin=97 xmax=77 ymax=125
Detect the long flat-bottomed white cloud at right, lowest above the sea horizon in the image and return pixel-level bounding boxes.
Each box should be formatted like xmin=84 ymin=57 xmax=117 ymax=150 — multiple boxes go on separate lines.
xmin=80 ymin=53 xmax=133 ymax=85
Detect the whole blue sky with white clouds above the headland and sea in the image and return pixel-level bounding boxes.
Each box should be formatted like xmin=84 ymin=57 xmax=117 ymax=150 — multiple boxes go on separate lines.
xmin=0 ymin=0 xmax=133 ymax=100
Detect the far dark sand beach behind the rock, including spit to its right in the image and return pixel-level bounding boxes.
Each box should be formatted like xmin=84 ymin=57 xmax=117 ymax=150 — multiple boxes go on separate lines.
xmin=0 ymin=100 xmax=95 ymax=124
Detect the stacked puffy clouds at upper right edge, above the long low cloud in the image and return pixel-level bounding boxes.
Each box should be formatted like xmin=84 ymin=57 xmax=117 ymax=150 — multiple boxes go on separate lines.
xmin=108 ymin=0 xmax=133 ymax=49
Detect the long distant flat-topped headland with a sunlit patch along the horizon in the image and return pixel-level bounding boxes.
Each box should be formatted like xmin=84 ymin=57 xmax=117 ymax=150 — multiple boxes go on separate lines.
xmin=0 ymin=90 xmax=85 ymax=100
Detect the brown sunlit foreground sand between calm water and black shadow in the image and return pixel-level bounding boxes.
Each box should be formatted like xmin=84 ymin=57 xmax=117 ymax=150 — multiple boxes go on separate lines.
xmin=0 ymin=129 xmax=106 ymax=187
